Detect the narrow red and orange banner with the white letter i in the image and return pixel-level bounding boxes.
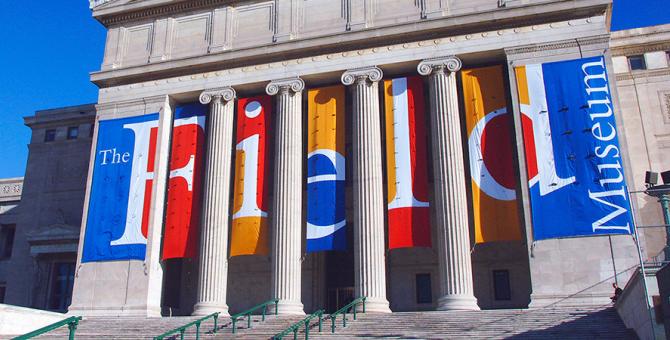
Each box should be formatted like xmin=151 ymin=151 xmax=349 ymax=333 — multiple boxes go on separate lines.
xmin=230 ymin=96 xmax=271 ymax=256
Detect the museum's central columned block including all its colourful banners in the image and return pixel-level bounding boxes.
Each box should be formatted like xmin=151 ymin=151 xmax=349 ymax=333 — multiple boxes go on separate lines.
xmin=3 ymin=0 xmax=663 ymax=316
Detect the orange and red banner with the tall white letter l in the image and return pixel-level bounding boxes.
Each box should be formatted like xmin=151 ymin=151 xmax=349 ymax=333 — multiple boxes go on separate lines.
xmin=384 ymin=77 xmax=431 ymax=249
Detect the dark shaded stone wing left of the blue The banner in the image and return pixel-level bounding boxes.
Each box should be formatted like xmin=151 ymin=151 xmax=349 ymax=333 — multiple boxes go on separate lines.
xmin=0 ymin=105 xmax=95 ymax=312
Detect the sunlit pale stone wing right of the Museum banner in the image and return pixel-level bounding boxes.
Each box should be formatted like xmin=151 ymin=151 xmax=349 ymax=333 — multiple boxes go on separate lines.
xmin=611 ymin=25 xmax=670 ymax=257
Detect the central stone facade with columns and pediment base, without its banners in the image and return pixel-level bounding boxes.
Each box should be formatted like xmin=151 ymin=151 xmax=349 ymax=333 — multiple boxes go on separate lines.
xmin=5 ymin=0 xmax=660 ymax=316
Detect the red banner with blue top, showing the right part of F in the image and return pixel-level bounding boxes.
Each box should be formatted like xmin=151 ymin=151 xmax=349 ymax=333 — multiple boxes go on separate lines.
xmin=162 ymin=104 xmax=207 ymax=260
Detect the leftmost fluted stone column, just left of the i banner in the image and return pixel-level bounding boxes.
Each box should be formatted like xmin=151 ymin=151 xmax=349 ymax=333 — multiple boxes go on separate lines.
xmin=193 ymin=87 xmax=235 ymax=316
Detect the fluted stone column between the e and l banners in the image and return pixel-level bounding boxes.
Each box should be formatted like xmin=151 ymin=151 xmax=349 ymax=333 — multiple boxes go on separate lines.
xmin=342 ymin=67 xmax=391 ymax=313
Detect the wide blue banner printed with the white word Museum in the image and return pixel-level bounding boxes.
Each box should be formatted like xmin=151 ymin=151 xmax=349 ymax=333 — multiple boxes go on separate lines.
xmin=515 ymin=56 xmax=631 ymax=240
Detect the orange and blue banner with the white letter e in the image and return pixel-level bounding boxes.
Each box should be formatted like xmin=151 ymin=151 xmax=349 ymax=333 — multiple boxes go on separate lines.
xmin=307 ymin=86 xmax=347 ymax=252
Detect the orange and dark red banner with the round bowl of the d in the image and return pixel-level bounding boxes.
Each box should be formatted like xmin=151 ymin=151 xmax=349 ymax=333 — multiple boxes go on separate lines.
xmin=468 ymin=66 xmax=521 ymax=243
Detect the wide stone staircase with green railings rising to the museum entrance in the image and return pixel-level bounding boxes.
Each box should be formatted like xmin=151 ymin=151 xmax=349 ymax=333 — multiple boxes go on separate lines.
xmin=13 ymin=306 xmax=636 ymax=340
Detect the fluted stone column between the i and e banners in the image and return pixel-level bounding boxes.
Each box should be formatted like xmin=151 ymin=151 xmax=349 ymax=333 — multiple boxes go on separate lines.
xmin=265 ymin=78 xmax=305 ymax=314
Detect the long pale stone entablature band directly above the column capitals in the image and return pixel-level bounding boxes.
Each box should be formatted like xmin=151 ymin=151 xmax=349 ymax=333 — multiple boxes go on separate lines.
xmin=92 ymin=16 xmax=606 ymax=105
